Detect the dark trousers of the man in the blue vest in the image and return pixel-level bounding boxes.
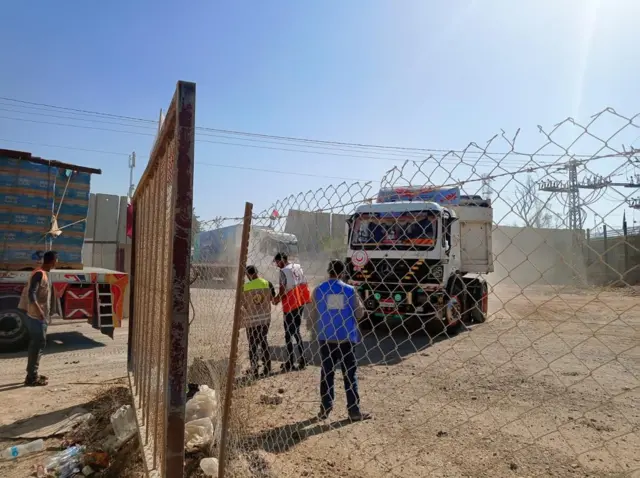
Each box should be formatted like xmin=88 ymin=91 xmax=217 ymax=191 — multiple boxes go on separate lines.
xmin=320 ymin=340 xmax=360 ymax=415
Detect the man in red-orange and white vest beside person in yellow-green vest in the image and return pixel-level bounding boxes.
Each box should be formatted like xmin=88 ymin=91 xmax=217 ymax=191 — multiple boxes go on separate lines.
xmin=273 ymin=253 xmax=311 ymax=372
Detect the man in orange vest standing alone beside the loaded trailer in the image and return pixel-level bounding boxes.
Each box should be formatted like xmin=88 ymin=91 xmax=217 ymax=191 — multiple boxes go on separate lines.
xmin=18 ymin=251 xmax=58 ymax=387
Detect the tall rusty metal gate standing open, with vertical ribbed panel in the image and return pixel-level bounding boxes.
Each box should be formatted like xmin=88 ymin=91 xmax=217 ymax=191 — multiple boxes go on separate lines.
xmin=128 ymin=82 xmax=195 ymax=477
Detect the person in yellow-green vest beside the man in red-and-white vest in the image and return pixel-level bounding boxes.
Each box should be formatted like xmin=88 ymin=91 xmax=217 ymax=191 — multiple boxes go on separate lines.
xmin=244 ymin=266 xmax=276 ymax=377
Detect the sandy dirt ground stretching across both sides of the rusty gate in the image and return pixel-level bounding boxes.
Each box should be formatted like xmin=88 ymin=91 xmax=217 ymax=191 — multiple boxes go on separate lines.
xmin=0 ymin=285 xmax=640 ymax=478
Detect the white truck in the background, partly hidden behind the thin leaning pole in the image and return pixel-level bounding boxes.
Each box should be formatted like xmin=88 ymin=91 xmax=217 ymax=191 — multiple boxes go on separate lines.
xmin=191 ymin=224 xmax=298 ymax=287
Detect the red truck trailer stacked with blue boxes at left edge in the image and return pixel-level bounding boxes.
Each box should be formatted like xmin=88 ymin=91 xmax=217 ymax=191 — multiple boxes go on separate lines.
xmin=0 ymin=149 xmax=128 ymax=352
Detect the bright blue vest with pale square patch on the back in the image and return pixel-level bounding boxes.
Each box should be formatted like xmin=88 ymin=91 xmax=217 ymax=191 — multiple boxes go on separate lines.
xmin=313 ymin=279 xmax=360 ymax=343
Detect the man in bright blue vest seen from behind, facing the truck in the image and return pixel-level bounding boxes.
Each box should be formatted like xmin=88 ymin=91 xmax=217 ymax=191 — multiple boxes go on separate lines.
xmin=311 ymin=261 xmax=371 ymax=421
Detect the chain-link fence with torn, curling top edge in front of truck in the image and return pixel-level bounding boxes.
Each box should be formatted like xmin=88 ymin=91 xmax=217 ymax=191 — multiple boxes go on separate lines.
xmin=186 ymin=109 xmax=640 ymax=477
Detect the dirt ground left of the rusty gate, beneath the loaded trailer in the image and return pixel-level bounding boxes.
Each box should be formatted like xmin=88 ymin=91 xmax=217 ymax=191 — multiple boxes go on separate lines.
xmin=0 ymin=323 xmax=127 ymax=478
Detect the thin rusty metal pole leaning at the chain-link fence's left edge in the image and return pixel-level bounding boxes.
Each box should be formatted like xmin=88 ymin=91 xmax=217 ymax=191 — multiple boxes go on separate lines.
xmin=218 ymin=202 xmax=253 ymax=478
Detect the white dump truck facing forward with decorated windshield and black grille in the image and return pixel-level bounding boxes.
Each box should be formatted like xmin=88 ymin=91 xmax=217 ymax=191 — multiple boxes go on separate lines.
xmin=346 ymin=187 xmax=493 ymax=331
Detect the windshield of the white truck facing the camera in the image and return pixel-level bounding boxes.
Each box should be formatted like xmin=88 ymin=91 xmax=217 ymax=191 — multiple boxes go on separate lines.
xmin=351 ymin=211 xmax=438 ymax=250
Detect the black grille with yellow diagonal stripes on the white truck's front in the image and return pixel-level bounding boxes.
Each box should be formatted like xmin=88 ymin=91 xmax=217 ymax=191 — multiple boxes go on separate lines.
xmin=347 ymin=259 xmax=442 ymax=284
